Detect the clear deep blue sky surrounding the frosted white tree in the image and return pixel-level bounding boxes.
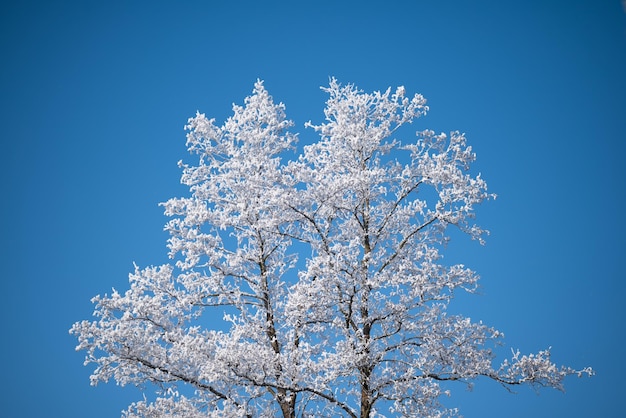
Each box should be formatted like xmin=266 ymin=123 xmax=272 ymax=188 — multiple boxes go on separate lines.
xmin=0 ymin=0 xmax=626 ymax=418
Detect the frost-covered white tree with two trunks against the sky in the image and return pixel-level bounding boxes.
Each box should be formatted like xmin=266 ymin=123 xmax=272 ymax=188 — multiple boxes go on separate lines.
xmin=70 ymin=79 xmax=592 ymax=417
